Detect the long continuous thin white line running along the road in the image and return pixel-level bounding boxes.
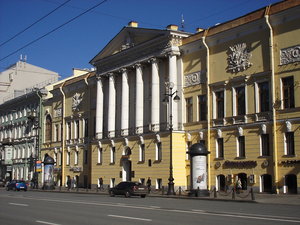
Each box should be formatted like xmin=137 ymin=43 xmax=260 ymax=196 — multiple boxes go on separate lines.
xmin=4 ymin=196 xmax=300 ymax=223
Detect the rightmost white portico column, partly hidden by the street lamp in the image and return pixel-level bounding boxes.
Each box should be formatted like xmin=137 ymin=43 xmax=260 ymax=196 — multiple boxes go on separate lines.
xmin=169 ymin=52 xmax=178 ymax=130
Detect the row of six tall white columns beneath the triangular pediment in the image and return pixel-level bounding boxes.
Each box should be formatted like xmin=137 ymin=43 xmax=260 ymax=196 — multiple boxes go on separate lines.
xmin=96 ymin=52 xmax=179 ymax=139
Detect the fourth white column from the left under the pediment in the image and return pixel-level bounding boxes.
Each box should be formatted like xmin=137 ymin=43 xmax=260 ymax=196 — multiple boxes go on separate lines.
xmin=135 ymin=64 xmax=144 ymax=133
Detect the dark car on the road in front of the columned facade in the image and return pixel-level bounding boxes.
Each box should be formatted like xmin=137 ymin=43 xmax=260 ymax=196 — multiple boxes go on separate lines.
xmin=109 ymin=181 xmax=148 ymax=198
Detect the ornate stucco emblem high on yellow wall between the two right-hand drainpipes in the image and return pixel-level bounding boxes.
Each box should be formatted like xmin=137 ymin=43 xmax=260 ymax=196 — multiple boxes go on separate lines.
xmin=227 ymin=43 xmax=252 ymax=73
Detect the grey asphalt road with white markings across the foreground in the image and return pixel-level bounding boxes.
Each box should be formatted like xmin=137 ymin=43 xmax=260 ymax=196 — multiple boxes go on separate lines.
xmin=0 ymin=190 xmax=300 ymax=225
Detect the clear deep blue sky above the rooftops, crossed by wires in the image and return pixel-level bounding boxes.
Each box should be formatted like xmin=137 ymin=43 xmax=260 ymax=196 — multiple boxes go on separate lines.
xmin=0 ymin=0 xmax=279 ymax=78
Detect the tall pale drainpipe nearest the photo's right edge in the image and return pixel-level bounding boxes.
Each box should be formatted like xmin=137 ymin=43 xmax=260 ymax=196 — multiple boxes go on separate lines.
xmin=265 ymin=6 xmax=279 ymax=194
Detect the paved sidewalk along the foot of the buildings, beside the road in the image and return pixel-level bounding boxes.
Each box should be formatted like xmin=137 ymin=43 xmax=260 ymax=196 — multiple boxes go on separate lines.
xmin=15 ymin=187 xmax=300 ymax=206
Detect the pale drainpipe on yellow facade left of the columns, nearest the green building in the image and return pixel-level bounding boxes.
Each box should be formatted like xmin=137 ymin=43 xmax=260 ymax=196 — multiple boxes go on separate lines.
xmin=59 ymin=82 xmax=66 ymax=186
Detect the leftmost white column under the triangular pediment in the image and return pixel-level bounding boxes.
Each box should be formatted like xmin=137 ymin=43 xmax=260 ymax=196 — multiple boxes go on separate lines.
xmin=96 ymin=76 xmax=103 ymax=139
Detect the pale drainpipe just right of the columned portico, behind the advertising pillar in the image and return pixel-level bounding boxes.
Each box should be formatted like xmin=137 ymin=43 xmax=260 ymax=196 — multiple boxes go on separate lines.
xmin=202 ymin=29 xmax=211 ymax=190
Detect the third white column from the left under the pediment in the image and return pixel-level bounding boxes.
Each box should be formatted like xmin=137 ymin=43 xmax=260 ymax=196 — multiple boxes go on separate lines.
xmin=121 ymin=69 xmax=129 ymax=135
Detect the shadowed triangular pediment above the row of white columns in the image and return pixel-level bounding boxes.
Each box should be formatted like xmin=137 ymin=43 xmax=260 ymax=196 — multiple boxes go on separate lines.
xmin=90 ymin=27 xmax=170 ymax=64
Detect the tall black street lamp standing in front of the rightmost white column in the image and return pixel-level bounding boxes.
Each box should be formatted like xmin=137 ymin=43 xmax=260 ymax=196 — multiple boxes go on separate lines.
xmin=163 ymin=82 xmax=180 ymax=195
